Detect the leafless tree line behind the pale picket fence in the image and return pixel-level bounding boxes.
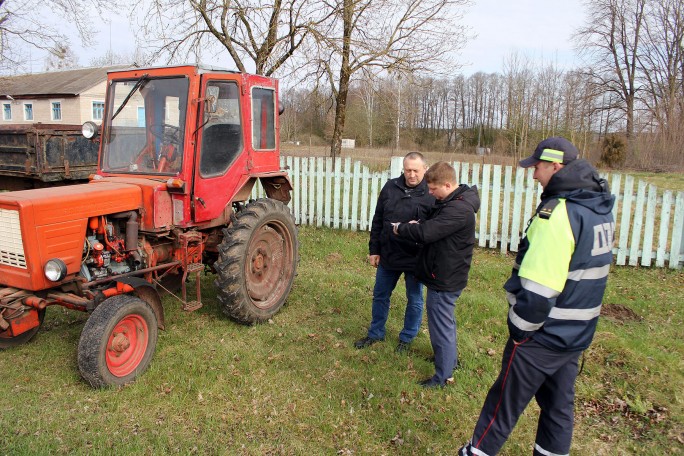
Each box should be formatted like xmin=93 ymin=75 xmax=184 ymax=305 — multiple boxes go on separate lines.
xmin=282 ymin=0 xmax=684 ymax=170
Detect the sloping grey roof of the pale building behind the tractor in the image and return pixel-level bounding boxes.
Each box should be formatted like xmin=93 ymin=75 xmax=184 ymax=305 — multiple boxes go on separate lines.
xmin=0 ymin=65 xmax=129 ymax=98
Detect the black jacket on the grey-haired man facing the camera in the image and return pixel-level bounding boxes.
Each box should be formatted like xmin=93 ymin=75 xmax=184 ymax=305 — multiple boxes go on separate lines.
xmin=368 ymin=174 xmax=435 ymax=272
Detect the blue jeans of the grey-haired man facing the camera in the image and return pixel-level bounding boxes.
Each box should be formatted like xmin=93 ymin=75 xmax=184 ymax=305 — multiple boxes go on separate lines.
xmin=368 ymin=266 xmax=423 ymax=343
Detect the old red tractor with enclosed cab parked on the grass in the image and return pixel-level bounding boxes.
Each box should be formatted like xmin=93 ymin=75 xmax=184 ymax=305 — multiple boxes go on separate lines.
xmin=0 ymin=66 xmax=299 ymax=387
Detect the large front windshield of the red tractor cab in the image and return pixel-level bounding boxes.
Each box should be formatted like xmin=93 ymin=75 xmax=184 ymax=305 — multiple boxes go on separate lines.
xmin=102 ymin=75 xmax=188 ymax=175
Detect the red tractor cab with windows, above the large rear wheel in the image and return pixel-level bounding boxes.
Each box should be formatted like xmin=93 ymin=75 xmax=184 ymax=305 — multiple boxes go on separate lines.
xmin=84 ymin=66 xmax=290 ymax=226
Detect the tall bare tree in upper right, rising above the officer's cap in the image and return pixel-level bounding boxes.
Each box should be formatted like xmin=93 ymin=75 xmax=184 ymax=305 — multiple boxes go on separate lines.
xmin=575 ymin=0 xmax=648 ymax=139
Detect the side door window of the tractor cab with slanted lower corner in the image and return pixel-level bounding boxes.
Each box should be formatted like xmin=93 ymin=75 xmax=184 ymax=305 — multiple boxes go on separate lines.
xmin=200 ymin=81 xmax=242 ymax=177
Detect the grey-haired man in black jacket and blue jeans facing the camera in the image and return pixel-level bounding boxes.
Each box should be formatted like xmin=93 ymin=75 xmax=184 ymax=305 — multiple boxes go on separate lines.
xmin=354 ymin=152 xmax=435 ymax=352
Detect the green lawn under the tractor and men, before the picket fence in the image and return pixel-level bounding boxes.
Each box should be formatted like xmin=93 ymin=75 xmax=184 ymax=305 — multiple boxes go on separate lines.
xmin=0 ymin=228 xmax=684 ymax=455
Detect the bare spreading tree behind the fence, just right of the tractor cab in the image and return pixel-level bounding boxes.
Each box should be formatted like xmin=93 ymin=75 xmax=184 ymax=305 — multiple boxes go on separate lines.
xmin=308 ymin=0 xmax=468 ymax=157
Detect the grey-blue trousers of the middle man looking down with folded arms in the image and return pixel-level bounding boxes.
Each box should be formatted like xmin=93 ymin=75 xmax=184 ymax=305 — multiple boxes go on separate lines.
xmin=426 ymin=288 xmax=463 ymax=384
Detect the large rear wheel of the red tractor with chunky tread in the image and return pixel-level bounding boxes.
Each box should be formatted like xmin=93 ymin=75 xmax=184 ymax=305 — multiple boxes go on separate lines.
xmin=214 ymin=198 xmax=299 ymax=324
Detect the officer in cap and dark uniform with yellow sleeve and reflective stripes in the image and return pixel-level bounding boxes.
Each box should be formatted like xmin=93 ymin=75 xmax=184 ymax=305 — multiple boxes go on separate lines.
xmin=458 ymin=137 xmax=615 ymax=456
